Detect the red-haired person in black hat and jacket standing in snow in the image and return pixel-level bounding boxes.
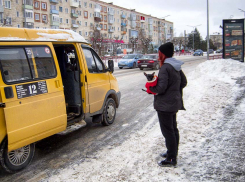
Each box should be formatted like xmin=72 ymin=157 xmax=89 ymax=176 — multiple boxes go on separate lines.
xmin=147 ymin=42 xmax=187 ymax=167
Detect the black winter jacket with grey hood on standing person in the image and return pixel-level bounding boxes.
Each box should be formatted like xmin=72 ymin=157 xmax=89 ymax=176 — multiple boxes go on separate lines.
xmin=150 ymin=58 xmax=187 ymax=112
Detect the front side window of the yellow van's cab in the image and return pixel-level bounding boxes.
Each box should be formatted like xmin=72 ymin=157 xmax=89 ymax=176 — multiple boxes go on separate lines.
xmin=83 ymin=48 xmax=104 ymax=73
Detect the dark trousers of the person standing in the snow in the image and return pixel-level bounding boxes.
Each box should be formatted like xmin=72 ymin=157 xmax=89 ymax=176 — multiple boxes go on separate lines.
xmin=157 ymin=111 xmax=179 ymax=159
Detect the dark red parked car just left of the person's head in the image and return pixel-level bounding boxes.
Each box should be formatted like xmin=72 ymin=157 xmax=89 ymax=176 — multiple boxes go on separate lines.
xmin=138 ymin=54 xmax=160 ymax=70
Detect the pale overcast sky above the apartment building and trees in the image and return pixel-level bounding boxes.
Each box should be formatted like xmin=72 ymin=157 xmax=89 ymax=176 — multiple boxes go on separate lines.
xmin=102 ymin=0 xmax=245 ymax=39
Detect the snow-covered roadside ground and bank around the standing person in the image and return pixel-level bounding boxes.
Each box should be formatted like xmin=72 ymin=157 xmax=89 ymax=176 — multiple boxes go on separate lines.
xmin=42 ymin=59 xmax=245 ymax=182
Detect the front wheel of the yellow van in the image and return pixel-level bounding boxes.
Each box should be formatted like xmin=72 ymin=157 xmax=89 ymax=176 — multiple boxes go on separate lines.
xmin=101 ymin=98 xmax=116 ymax=126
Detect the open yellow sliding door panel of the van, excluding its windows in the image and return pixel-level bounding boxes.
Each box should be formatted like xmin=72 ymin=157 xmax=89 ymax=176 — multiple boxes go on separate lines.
xmin=0 ymin=42 xmax=67 ymax=151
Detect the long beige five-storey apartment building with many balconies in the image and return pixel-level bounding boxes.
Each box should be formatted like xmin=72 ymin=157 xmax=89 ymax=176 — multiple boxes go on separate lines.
xmin=0 ymin=0 xmax=173 ymax=46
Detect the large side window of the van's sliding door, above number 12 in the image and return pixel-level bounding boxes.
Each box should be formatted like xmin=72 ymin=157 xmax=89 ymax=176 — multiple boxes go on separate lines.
xmin=0 ymin=46 xmax=56 ymax=83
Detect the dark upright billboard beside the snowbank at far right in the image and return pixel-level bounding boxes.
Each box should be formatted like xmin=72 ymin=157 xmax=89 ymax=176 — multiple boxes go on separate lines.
xmin=223 ymin=19 xmax=244 ymax=62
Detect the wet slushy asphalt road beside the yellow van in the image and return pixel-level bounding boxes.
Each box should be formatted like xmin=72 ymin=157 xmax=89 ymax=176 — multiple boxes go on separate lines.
xmin=0 ymin=56 xmax=206 ymax=182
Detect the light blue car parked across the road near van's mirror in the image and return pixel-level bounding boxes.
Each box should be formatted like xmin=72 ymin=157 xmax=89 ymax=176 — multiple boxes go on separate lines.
xmin=118 ymin=54 xmax=143 ymax=69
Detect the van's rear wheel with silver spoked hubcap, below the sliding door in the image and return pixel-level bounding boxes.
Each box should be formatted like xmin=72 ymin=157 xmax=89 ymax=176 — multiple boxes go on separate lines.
xmin=0 ymin=140 xmax=35 ymax=173
